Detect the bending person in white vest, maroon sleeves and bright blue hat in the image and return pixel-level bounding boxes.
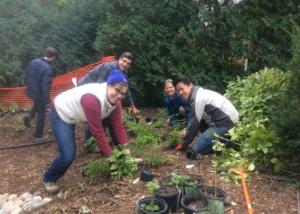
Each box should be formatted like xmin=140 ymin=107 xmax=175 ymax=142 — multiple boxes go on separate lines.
xmin=43 ymin=69 xmax=130 ymax=193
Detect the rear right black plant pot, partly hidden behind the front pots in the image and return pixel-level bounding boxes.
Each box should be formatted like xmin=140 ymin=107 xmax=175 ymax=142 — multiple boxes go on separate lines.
xmin=201 ymin=186 xmax=231 ymax=206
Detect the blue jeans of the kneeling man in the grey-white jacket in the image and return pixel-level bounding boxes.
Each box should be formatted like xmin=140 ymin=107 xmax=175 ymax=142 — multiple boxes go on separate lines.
xmin=192 ymin=126 xmax=232 ymax=155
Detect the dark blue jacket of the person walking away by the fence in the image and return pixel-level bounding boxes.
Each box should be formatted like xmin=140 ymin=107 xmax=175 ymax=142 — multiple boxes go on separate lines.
xmin=24 ymin=58 xmax=53 ymax=104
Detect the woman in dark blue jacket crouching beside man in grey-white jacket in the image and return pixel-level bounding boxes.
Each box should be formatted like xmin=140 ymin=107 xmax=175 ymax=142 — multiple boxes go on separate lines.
xmin=164 ymin=79 xmax=189 ymax=128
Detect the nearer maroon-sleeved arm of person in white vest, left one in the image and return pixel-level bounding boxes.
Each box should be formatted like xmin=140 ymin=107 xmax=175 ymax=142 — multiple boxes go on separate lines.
xmin=81 ymin=94 xmax=112 ymax=156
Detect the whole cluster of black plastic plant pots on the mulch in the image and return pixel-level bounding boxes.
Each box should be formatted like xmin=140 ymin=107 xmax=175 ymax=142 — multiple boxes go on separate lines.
xmin=137 ymin=174 xmax=230 ymax=214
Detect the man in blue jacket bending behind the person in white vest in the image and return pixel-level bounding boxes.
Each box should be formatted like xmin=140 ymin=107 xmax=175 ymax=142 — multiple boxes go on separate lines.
xmin=77 ymin=52 xmax=139 ymax=144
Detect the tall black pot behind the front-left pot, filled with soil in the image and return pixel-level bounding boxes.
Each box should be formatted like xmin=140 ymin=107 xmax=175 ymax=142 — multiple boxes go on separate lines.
xmin=155 ymin=185 xmax=180 ymax=213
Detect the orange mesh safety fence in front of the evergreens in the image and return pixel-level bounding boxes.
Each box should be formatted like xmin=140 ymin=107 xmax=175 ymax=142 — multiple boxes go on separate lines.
xmin=0 ymin=56 xmax=116 ymax=110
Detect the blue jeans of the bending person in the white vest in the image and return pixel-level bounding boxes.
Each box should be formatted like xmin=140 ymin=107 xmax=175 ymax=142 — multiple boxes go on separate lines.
xmin=43 ymin=106 xmax=76 ymax=182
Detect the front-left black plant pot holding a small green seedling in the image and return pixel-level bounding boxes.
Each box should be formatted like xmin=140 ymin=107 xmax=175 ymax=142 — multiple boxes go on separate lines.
xmin=137 ymin=196 xmax=168 ymax=214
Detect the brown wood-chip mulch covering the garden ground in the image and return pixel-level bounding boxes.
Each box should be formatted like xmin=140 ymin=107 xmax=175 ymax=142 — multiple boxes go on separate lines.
xmin=0 ymin=109 xmax=297 ymax=214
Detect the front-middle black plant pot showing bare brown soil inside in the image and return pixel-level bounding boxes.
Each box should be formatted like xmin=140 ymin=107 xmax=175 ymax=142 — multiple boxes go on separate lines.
xmin=181 ymin=194 xmax=208 ymax=214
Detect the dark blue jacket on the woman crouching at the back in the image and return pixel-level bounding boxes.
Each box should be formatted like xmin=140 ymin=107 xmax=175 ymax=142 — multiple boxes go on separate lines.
xmin=164 ymin=93 xmax=189 ymax=118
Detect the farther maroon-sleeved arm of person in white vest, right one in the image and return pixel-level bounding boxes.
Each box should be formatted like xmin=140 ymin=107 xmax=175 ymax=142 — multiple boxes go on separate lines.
xmin=109 ymin=104 xmax=128 ymax=145
